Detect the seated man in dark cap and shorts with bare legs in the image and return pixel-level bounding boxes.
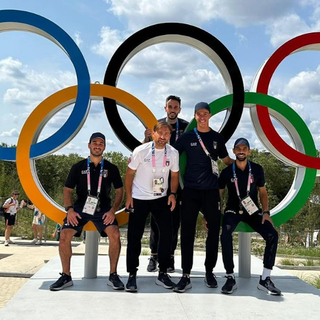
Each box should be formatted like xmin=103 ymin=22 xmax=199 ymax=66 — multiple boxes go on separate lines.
xmin=50 ymin=132 xmax=124 ymax=291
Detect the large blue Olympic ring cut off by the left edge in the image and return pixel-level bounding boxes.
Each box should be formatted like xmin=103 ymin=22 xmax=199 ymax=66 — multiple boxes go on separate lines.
xmin=0 ymin=10 xmax=90 ymax=161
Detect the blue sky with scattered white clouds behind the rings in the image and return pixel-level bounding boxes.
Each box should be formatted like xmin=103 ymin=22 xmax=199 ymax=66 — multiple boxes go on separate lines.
xmin=0 ymin=0 xmax=320 ymax=156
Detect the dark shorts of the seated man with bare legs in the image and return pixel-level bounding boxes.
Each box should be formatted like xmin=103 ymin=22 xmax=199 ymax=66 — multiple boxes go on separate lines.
xmin=62 ymin=208 xmax=118 ymax=237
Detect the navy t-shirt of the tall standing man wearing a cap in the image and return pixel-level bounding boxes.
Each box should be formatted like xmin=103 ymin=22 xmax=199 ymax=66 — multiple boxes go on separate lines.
xmin=173 ymin=129 xmax=228 ymax=190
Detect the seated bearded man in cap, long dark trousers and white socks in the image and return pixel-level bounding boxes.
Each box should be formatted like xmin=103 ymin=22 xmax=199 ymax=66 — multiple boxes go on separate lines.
xmin=219 ymin=138 xmax=281 ymax=295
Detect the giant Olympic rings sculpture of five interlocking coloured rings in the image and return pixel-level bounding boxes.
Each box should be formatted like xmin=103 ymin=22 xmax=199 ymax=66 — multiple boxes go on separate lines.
xmin=0 ymin=10 xmax=320 ymax=231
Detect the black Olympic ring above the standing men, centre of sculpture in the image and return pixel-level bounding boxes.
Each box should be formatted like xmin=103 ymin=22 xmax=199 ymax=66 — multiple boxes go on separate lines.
xmin=103 ymin=23 xmax=244 ymax=150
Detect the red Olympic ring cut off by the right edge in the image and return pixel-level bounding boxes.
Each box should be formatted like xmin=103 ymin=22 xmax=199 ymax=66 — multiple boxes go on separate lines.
xmin=256 ymin=32 xmax=320 ymax=169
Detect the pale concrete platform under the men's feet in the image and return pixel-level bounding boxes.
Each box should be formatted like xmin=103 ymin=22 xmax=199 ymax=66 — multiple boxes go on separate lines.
xmin=0 ymin=255 xmax=320 ymax=320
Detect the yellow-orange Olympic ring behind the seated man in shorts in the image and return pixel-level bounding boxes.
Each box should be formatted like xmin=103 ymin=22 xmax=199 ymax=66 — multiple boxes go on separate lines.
xmin=16 ymin=84 xmax=157 ymax=231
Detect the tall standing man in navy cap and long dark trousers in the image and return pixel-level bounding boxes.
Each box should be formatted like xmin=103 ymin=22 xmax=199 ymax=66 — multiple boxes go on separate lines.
xmin=173 ymin=102 xmax=233 ymax=292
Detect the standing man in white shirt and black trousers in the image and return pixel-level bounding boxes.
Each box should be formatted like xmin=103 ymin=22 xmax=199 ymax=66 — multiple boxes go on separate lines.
xmin=125 ymin=122 xmax=179 ymax=292
